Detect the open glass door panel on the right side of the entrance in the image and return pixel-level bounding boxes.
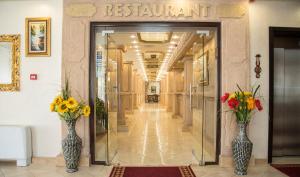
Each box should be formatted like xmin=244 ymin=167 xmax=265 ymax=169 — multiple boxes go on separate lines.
xmin=190 ymin=29 xmax=218 ymax=165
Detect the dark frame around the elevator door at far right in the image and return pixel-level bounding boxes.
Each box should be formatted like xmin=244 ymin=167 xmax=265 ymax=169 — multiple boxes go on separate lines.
xmin=268 ymin=27 xmax=300 ymax=163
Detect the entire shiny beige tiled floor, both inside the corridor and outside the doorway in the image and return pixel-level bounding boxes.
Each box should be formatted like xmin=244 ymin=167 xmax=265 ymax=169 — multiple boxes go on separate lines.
xmin=0 ymin=104 xmax=285 ymax=177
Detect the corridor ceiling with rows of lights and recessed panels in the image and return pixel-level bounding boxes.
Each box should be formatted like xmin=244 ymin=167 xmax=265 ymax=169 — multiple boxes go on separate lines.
xmin=110 ymin=32 xmax=183 ymax=81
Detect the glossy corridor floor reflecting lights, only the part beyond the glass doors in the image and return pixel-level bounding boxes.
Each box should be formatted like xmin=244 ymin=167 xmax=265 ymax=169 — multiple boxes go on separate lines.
xmin=114 ymin=104 xmax=211 ymax=165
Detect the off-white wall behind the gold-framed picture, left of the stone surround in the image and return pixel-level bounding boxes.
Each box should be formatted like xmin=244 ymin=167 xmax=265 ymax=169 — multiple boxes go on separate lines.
xmin=0 ymin=0 xmax=63 ymax=157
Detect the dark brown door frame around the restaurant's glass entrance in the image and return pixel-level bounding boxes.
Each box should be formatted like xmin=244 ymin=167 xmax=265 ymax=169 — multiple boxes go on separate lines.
xmin=89 ymin=21 xmax=222 ymax=165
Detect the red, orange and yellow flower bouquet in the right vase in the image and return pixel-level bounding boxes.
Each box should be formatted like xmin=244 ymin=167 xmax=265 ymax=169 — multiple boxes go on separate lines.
xmin=221 ymin=85 xmax=263 ymax=123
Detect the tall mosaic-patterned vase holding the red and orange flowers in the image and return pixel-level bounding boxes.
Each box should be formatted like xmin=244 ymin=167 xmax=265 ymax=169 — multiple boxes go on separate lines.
xmin=232 ymin=123 xmax=253 ymax=175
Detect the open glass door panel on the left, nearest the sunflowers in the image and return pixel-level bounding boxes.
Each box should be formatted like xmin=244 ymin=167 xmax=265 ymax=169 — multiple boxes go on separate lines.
xmin=94 ymin=28 xmax=119 ymax=164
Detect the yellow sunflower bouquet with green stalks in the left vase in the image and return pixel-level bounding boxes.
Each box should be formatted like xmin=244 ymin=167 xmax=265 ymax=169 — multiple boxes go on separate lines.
xmin=50 ymin=81 xmax=91 ymax=121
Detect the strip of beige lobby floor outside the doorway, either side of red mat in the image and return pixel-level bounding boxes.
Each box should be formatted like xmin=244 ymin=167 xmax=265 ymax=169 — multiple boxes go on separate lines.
xmin=0 ymin=163 xmax=285 ymax=177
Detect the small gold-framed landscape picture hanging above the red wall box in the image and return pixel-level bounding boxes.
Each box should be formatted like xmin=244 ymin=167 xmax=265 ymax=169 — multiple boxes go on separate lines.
xmin=25 ymin=17 xmax=51 ymax=57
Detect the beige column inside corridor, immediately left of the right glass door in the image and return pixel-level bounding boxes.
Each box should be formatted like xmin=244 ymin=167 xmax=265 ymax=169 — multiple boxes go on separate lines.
xmin=182 ymin=55 xmax=193 ymax=131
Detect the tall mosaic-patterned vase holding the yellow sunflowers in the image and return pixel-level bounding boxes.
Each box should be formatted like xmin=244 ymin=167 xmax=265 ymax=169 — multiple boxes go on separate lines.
xmin=62 ymin=120 xmax=82 ymax=173
